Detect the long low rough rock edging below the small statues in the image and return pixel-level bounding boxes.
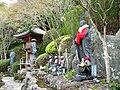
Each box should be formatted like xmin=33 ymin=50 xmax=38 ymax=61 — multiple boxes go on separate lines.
xmin=40 ymin=75 xmax=108 ymax=90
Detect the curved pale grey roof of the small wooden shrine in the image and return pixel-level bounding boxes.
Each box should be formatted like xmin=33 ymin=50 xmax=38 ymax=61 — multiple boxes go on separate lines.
xmin=13 ymin=28 xmax=46 ymax=37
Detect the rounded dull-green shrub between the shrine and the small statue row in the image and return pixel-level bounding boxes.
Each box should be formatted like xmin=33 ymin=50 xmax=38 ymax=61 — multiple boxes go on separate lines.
xmin=35 ymin=53 xmax=48 ymax=67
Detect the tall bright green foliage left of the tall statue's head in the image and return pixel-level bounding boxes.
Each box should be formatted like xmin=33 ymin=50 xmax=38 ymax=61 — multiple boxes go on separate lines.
xmin=60 ymin=6 xmax=84 ymax=35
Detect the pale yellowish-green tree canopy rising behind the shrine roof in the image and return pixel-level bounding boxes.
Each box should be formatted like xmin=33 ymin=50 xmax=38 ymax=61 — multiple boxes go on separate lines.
xmin=0 ymin=0 xmax=75 ymax=58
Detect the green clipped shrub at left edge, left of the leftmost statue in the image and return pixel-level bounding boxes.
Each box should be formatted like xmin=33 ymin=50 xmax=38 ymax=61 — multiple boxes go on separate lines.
xmin=0 ymin=59 xmax=10 ymax=72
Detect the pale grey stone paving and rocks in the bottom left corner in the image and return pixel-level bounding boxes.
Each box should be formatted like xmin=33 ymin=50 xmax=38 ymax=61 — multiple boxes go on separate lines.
xmin=0 ymin=70 xmax=48 ymax=90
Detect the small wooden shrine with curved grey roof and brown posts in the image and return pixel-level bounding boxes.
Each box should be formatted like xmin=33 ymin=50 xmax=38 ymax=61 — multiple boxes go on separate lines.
xmin=14 ymin=28 xmax=46 ymax=67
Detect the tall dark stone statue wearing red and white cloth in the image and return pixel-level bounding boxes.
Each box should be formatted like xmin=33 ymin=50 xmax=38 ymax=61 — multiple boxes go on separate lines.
xmin=75 ymin=20 xmax=92 ymax=62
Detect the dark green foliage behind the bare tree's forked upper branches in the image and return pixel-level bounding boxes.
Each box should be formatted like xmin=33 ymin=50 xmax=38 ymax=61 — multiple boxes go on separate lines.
xmin=91 ymin=0 xmax=120 ymax=35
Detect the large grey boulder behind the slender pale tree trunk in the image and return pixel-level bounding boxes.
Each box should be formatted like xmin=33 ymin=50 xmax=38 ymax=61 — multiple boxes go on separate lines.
xmin=93 ymin=36 xmax=120 ymax=81
